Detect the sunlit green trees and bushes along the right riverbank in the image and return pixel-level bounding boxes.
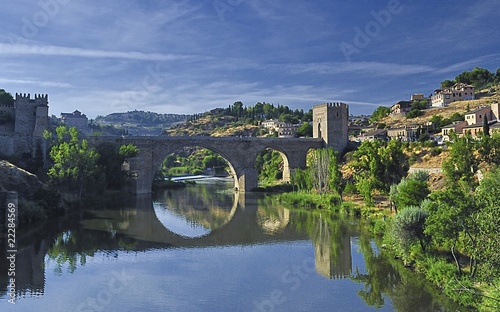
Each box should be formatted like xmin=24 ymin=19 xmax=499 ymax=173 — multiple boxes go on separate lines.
xmin=270 ymin=132 xmax=500 ymax=311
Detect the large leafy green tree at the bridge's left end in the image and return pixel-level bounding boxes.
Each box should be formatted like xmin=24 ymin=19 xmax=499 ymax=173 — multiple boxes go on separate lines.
xmin=46 ymin=126 xmax=99 ymax=197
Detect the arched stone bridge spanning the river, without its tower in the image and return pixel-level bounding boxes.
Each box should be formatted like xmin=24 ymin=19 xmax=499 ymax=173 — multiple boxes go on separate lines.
xmin=89 ymin=136 xmax=324 ymax=194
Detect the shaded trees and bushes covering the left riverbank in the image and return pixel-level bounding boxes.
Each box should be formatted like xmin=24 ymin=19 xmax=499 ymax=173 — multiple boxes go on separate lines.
xmin=2 ymin=126 xmax=139 ymax=224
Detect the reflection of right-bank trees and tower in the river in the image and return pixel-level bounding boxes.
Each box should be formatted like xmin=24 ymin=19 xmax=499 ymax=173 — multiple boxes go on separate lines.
xmin=284 ymin=205 xmax=457 ymax=311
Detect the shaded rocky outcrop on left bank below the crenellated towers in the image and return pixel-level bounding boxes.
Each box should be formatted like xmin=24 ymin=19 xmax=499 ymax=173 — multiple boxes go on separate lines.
xmin=0 ymin=160 xmax=44 ymax=199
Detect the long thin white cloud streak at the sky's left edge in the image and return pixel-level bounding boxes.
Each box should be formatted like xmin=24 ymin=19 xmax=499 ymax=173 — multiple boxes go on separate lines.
xmin=0 ymin=43 xmax=197 ymax=61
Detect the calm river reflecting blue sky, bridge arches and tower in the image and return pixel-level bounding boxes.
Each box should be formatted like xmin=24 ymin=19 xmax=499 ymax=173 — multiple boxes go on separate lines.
xmin=0 ymin=179 xmax=462 ymax=312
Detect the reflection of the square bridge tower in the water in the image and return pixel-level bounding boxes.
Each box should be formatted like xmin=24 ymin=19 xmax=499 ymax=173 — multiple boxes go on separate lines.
xmin=313 ymin=219 xmax=352 ymax=278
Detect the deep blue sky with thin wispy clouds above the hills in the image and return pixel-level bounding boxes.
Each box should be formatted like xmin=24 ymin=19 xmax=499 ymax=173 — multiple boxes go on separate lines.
xmin=0 ymin=0 xmax=500 ymax=117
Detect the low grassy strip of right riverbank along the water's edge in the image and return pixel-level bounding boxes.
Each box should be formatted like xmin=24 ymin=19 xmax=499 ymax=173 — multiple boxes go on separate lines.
xmin=274 ymin=193 xmax=500 ymax=311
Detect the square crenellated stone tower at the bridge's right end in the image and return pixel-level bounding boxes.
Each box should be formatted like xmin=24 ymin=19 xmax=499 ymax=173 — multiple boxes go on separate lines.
xmin=313 ymin=102 xmax=349 ymax=153
